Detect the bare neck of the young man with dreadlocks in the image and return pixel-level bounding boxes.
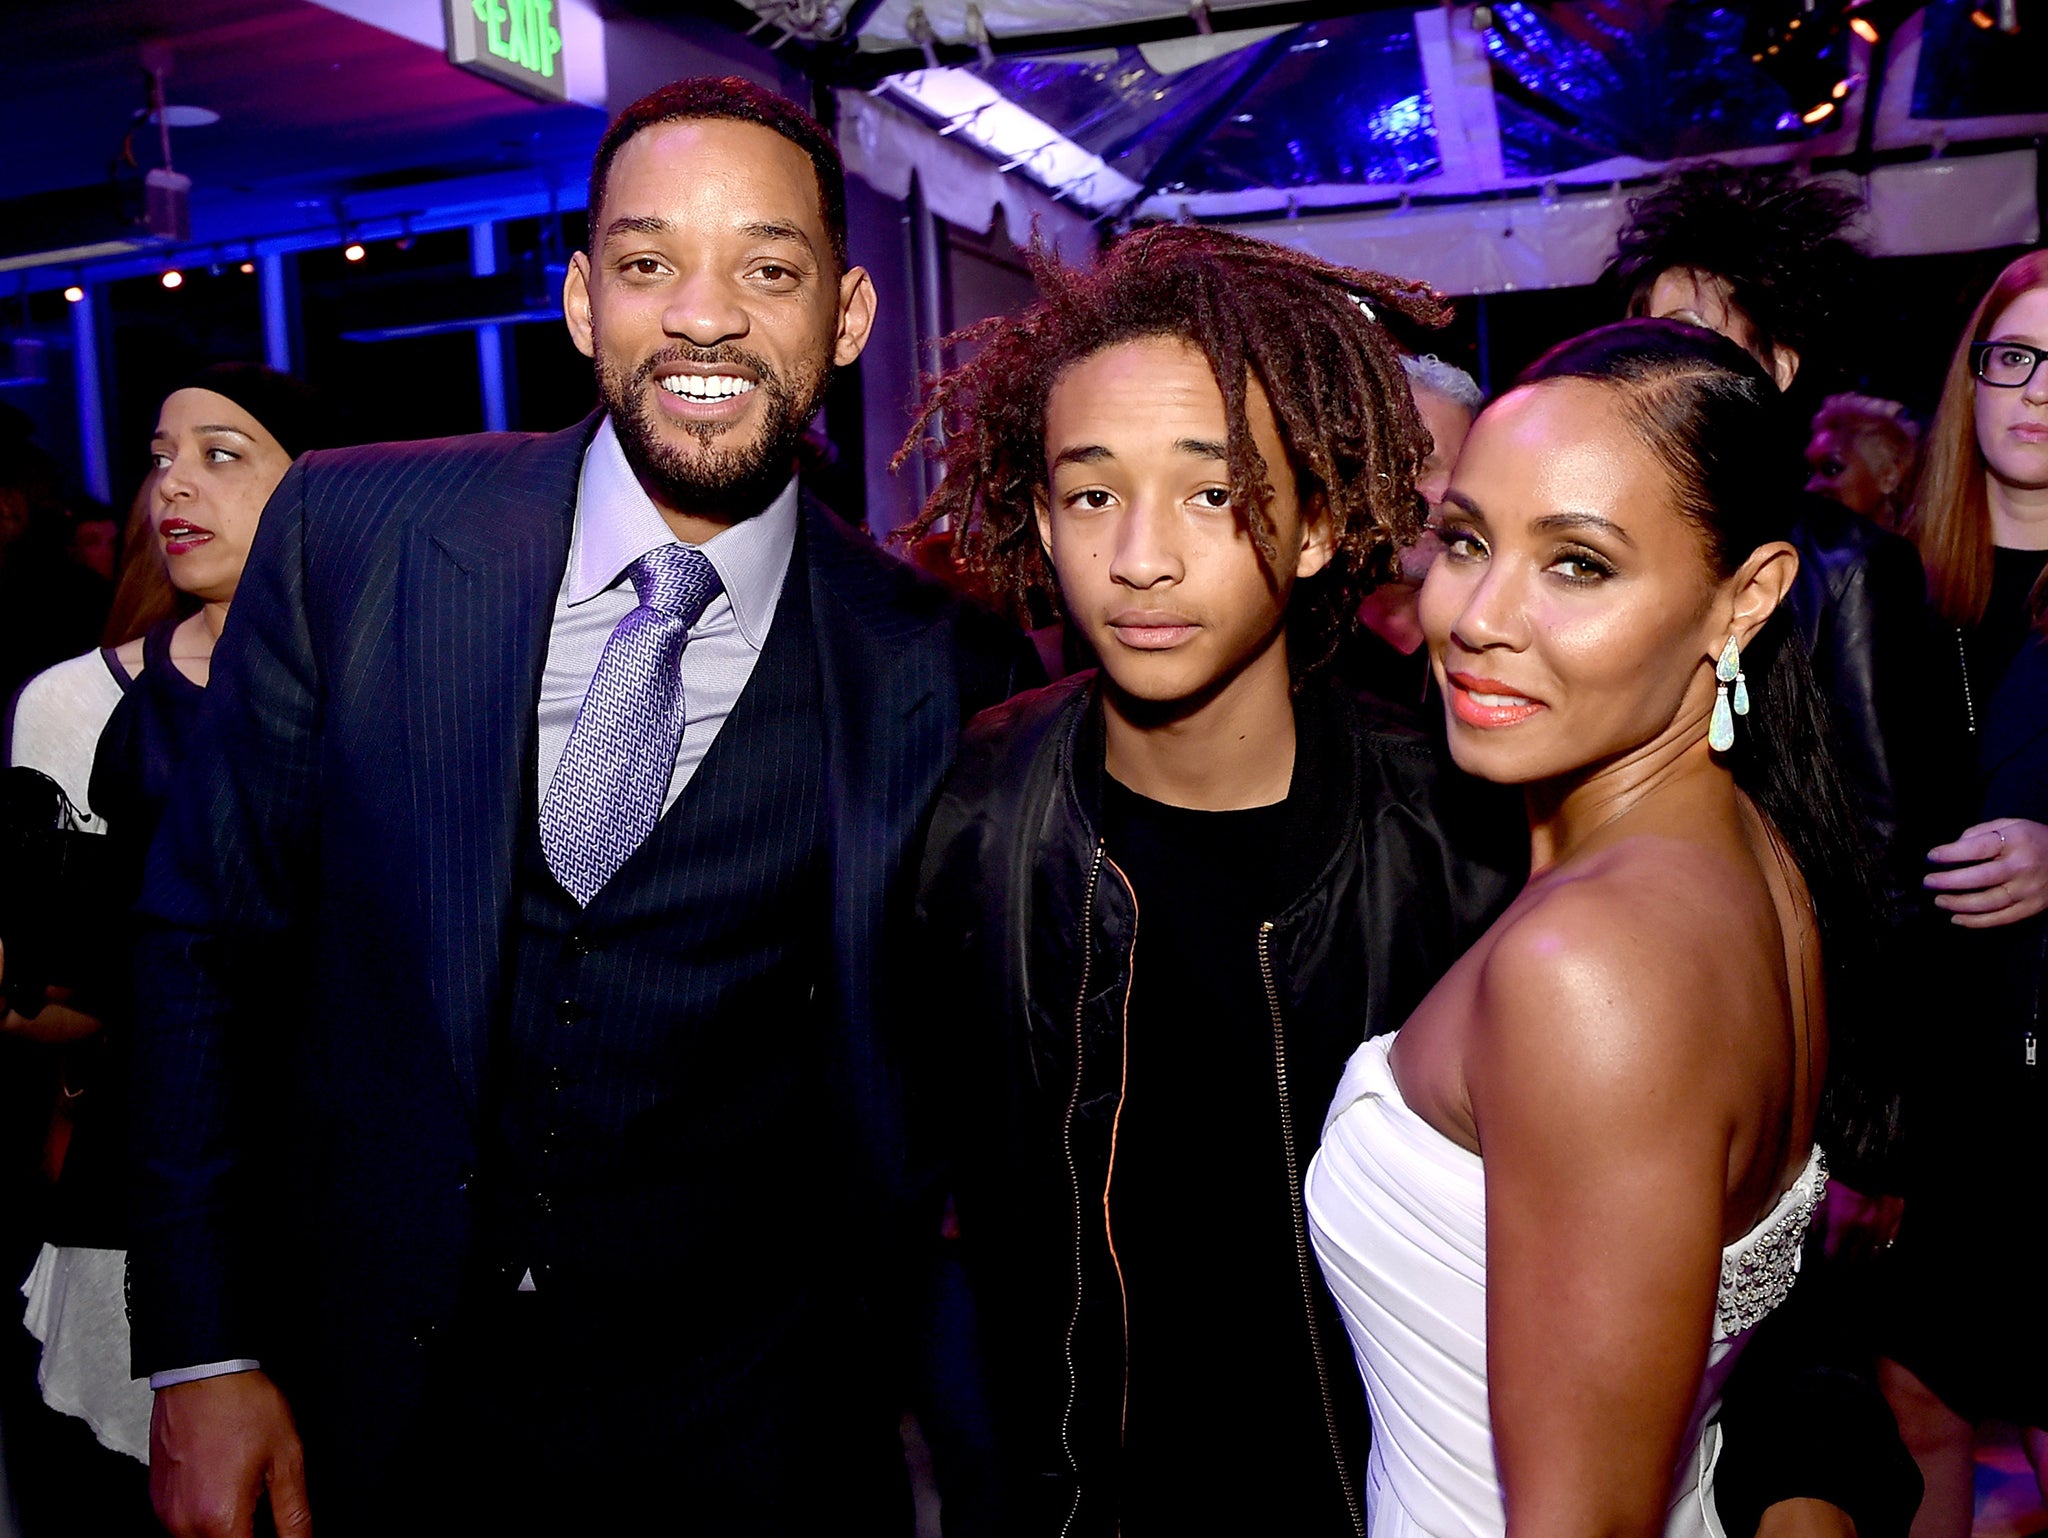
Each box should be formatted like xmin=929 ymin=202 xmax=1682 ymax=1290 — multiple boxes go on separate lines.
xmin=1102 ymin=645 xmax=1294 ymax=811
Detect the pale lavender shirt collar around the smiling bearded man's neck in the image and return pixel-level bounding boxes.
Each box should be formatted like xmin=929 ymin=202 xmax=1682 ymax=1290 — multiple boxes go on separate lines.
xmin=563 ymin=416 xmax=797 ymax=651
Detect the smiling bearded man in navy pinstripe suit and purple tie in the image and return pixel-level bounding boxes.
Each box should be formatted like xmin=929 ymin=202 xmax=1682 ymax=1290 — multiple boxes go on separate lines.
xmin=131 ymin=80 xmax=1036 ymax=1538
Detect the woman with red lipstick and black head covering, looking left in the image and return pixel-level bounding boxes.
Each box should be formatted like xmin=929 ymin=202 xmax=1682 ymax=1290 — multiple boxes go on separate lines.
xmin=6 ymin=362 xmax=319 ymax=1534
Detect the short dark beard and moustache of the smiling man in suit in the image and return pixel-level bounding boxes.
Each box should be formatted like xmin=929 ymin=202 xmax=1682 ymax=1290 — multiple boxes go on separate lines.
xmin=596 ymin=346 xmax=831 ymax=522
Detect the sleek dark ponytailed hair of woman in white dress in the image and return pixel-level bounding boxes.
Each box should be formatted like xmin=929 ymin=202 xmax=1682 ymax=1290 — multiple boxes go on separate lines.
xmin=1516 ymin=319 xmax=1898 ymax=1169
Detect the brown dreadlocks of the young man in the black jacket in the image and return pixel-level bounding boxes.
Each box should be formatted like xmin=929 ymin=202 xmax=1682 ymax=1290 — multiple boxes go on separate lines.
xmin=891 ymin=225 xmax=1450 ymax=678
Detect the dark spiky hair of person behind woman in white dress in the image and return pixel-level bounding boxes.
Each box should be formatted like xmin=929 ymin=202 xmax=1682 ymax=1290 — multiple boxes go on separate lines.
xmin=1608 ymin=160 xmax=1864 ymax=382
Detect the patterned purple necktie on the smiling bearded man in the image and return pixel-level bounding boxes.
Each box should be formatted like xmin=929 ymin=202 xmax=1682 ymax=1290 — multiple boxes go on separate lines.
xmin=541 ymin=545 xmax=721 ymax=907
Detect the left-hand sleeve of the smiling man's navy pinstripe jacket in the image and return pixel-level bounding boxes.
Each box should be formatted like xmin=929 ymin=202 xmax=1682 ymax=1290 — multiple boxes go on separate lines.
xmin=129 ymin=461 xmax=322 ymax=1374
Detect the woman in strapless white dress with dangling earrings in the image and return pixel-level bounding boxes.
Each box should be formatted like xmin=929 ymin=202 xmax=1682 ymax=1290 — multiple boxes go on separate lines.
xmin=1307 ymin=322 xmax=1882 ymax=1538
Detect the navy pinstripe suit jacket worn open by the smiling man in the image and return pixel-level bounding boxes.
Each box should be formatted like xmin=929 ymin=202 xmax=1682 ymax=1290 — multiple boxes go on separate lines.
xmin=131 ymin=418 xmax=1042 ymax=1441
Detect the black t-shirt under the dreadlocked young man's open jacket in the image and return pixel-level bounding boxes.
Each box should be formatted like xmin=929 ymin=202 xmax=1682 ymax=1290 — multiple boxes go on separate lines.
xmin=1104 ymin=760 xmax=1356 ymax=1538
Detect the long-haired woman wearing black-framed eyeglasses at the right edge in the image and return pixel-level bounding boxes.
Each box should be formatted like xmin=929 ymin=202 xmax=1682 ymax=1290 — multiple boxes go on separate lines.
xmin=1880 ymin=252 xmax=2048 ymax=1538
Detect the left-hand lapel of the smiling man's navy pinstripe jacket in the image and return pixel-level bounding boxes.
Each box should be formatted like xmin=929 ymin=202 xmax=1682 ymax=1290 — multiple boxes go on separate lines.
xmin=399 ymin=416 xmax=598 ymax=1110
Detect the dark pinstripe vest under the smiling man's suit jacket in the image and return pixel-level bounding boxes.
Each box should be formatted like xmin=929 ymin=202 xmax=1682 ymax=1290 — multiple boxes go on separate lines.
xmin=485 ymin=539 xmax=846 ymax=1317
